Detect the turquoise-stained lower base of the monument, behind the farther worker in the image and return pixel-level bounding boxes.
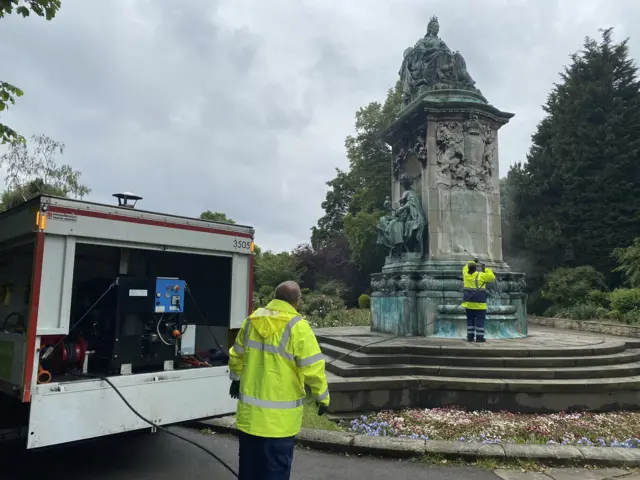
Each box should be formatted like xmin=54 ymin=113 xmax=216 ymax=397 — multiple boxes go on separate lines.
xmin=371 ymin=253 xmax=527 ymax=339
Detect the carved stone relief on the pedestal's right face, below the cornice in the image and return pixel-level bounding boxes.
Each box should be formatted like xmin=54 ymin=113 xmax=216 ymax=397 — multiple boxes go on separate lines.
xmin=436 ymin=114 xmax=496 ymax=192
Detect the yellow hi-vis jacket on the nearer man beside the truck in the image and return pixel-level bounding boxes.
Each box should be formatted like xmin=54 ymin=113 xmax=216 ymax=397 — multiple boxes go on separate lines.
xmin=229 ymin=300 xmax=329 ymax=438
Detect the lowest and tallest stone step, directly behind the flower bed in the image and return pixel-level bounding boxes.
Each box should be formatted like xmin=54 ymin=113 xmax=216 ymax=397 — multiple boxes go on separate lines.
xmin=327 ymin=373 xmax=640 ymax=414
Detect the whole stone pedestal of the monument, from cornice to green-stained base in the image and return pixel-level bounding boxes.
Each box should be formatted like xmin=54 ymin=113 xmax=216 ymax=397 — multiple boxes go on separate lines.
xmin=371 ymin=91 xmax=527 ymax=338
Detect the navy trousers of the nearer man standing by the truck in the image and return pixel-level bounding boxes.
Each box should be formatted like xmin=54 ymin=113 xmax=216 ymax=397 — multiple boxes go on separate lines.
xmin=238 ymin=432 xmax=295 ymax=480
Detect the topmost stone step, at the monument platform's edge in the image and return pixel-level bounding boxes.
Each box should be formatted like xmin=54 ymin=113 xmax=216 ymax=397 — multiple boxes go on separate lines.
xmin=316 ymin=334 xmax=627 ymax=358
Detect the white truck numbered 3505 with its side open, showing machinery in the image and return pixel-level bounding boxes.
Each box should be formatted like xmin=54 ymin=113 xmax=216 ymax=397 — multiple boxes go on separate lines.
xmin=0 ymin=194 xmax=254 ymax=449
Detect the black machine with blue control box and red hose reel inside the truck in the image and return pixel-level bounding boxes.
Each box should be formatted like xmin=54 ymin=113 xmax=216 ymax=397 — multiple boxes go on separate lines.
xmin=43 ymin=276 xmax=196 ymax=375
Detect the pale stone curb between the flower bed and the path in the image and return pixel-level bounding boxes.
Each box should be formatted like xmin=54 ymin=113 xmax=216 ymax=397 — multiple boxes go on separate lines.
xmin=195 ymin=417 xmax=640 ymax=468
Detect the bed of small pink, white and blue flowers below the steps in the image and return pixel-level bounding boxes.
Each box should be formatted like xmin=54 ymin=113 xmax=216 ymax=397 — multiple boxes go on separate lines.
xmin=341 ymin=408 xmax=640 ymax=448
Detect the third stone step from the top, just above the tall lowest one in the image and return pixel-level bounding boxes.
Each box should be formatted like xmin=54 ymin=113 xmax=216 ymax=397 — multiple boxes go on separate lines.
xmin=325 ymin=356 xmax=640 ymax=380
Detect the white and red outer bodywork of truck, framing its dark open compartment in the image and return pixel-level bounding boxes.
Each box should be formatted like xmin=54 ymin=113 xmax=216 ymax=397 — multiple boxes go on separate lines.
xmin=0 ymin=196 xmax=254 ymax=448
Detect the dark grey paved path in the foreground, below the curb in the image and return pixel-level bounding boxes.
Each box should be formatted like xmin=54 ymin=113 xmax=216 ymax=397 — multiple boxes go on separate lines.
xmin=0 ymin=428 xmax=640 ymax=480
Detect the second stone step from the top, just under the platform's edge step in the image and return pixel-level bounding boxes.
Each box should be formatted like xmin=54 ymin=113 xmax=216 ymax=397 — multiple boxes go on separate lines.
xmin=320 ymin=342 xmax=640 ymax=368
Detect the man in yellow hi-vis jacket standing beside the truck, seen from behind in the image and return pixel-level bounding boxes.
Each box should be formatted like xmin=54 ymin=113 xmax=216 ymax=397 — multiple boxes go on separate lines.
xmin=229 ymin=281 xmax=329 ymax=480
